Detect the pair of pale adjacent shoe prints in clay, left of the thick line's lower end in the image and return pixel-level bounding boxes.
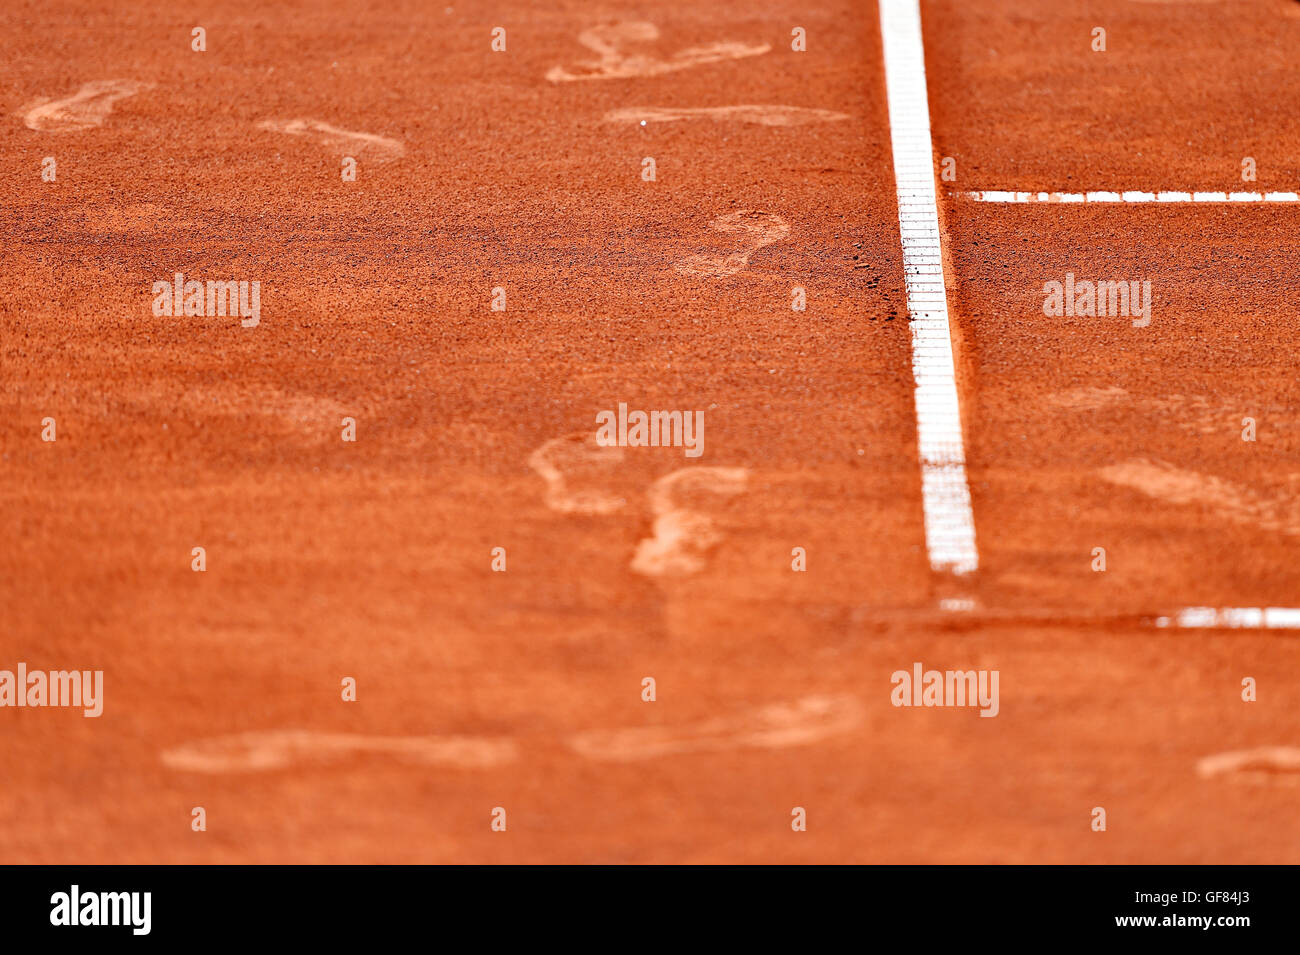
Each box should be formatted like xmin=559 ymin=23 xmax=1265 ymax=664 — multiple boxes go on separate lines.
xmin=528 ymin=431 xmax=749 ymax=577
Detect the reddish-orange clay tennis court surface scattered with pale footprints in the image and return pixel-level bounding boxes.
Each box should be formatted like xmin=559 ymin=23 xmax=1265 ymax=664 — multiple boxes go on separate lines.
xmin=0 ymin=0 xmax=1300 ymax=863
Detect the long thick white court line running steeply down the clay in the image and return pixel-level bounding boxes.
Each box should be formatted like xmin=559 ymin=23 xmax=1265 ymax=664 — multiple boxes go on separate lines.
xmin=880 ymin=0 xmax=979 ymax=574
